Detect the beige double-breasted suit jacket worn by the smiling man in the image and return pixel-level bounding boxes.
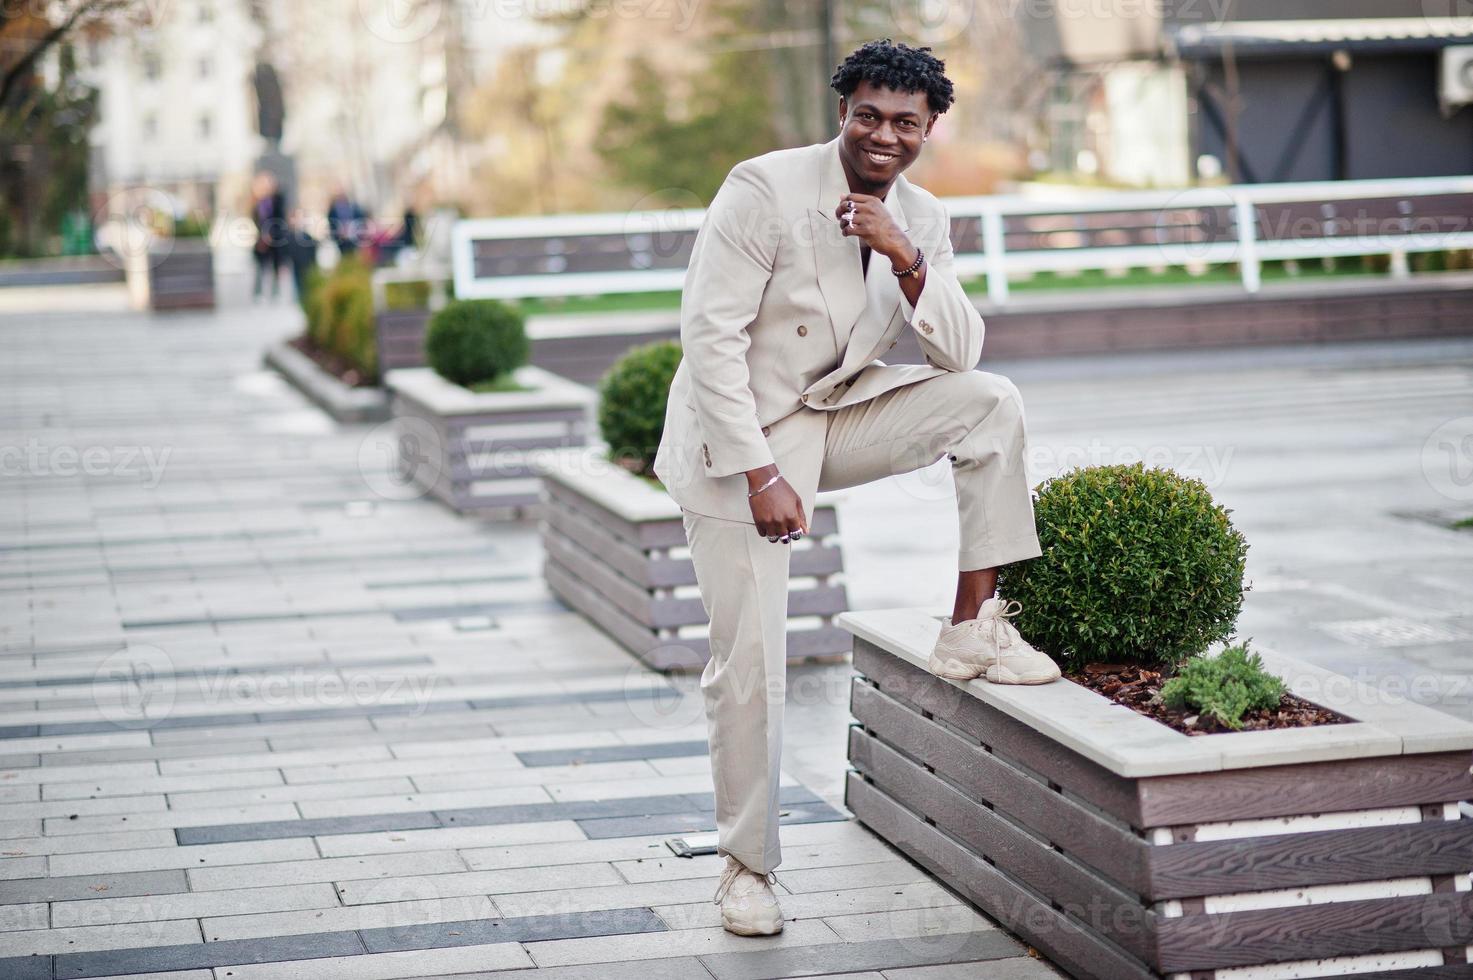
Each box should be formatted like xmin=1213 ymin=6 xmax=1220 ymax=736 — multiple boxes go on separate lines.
xmin=654 ymin=137 xmax=982 ymax=522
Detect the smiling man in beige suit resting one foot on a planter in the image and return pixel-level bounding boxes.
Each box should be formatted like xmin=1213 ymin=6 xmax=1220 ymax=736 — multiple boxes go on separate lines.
xmin=654 ymin=40 xmax=1059 ymax=936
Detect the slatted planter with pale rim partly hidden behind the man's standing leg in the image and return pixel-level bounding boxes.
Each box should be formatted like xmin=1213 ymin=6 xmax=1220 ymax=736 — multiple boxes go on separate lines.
xmin=536 ymin=448 xmax=850 ymax=671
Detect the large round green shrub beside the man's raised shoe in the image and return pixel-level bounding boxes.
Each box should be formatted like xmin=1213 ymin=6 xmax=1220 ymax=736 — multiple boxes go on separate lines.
xmin=999 ymin=463 xmax=1248 ymax=669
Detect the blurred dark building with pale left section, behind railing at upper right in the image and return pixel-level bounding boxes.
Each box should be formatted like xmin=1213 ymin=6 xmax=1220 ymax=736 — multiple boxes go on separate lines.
xmin=1019 ymin=0 xmax=1473 ymax=186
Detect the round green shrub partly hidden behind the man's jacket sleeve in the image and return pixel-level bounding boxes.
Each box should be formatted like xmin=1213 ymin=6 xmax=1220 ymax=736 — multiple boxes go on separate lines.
xmin=598 ymin=340 xmax=681 ymax=476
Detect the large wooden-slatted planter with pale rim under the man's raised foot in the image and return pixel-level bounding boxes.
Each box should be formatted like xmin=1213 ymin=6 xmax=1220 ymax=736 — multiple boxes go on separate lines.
xmin=838 ymin=609 xmax=1473 ymax=980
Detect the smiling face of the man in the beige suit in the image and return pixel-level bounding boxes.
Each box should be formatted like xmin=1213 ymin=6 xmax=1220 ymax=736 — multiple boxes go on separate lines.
xmin=838 ymin=81 xmax=935 ymax=197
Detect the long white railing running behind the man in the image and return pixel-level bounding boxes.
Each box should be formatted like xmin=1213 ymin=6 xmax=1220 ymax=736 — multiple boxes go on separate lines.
xmin=452 ymin=177 xmax=1473 ymax=304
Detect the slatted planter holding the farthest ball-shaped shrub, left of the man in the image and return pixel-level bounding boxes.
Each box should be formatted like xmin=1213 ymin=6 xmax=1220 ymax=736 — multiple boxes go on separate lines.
xmin=384 ymin=365 xmax=597 ymax=519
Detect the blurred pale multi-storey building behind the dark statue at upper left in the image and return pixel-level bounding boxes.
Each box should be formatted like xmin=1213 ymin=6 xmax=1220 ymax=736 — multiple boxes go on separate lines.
xmin=82 ymin=0 xmax=524 ymax=225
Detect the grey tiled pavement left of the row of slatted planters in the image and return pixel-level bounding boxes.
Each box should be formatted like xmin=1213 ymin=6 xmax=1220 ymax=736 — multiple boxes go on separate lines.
xmin=0 ymin=294 xmax=1056 ymax=980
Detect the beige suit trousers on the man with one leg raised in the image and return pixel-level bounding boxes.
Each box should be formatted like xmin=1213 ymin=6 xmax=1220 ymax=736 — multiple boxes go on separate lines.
xmin=683 ymin=371 xmax=1040 ymax=874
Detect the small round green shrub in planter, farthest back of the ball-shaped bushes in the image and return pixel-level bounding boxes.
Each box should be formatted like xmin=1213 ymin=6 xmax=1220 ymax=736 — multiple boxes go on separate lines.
xmin=424 ymin=299 xmax=530 ymax=388
